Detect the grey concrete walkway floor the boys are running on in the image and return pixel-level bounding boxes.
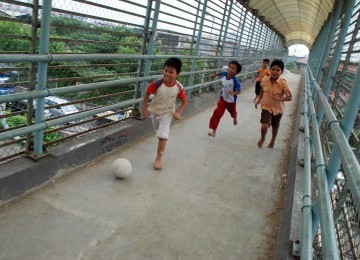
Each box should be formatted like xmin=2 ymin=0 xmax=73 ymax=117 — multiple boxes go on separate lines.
xmin=0 ymin=74 xmax=300 ymax=260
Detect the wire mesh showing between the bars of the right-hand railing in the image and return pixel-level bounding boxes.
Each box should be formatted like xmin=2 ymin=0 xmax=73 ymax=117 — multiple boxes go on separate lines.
xmin=314 ymin=1 xmax=360 ymax=259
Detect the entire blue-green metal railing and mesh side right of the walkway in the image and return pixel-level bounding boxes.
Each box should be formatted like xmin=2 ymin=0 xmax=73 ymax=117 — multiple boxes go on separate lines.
xmin=301 ymin=0 xmax=360 ymax=259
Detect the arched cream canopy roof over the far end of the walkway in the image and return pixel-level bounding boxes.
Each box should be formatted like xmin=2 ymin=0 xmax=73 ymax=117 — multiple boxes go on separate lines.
xmin=240 ymin=0 xmax=335 ymax=49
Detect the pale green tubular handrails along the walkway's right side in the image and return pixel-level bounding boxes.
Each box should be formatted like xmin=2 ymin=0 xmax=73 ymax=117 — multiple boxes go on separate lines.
xmin=301 ymin=67 xmax=360 ymax=259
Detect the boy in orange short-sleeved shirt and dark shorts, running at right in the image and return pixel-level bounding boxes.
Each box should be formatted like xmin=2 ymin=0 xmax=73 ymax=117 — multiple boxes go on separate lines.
xmin=255 ymin=60 xmax=292 ymax=148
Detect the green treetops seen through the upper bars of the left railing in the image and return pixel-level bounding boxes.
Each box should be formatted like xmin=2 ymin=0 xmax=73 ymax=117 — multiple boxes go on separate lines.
xmin=0 ymin=16 xmax=148 ymax=103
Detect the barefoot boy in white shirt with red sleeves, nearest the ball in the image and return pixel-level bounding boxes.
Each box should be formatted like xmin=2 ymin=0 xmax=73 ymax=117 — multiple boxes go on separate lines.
xmin=143 ymin=57 xmax=187 ymax=170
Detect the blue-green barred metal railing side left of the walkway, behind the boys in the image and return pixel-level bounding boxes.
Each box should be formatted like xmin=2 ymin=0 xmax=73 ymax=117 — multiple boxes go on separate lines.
xmin=0 ymin=0 xmax=287 ymax=163
